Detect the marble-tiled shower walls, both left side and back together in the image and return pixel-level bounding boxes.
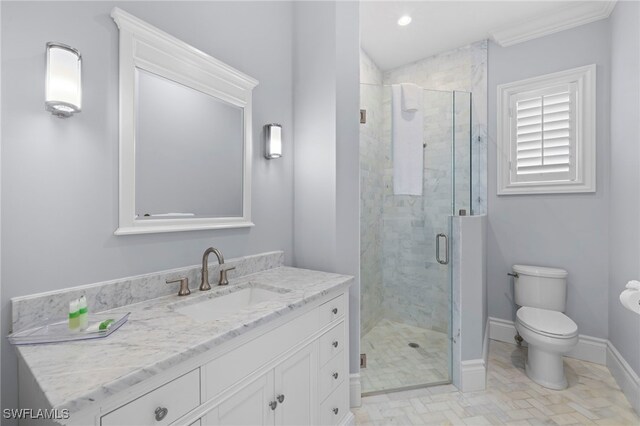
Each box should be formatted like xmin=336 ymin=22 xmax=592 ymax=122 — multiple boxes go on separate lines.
xmin=361 ymin=41 xmax=487 ymax=335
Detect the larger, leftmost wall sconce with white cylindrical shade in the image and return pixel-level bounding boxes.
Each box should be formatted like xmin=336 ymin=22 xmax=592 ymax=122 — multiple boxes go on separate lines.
xmin=44 ymin=42 xmax=82 ymax=118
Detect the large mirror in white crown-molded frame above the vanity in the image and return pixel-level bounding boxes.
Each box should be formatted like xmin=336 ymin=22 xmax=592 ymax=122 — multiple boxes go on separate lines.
xmin=111 ymin=8 xmax=258 ymax=235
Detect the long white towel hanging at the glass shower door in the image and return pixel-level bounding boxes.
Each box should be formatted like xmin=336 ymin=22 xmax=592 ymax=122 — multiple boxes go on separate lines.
xmin=391 ymin=84 xmax=424 ymax=195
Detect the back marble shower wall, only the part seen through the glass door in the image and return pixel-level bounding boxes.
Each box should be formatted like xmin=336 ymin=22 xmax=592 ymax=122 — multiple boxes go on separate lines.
xmin=383 ymin=86 xmax=453 ymax=333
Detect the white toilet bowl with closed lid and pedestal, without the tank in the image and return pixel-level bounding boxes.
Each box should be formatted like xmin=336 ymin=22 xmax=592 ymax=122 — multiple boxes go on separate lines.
xmin=516 ymin=306 xmax=578 ymax=390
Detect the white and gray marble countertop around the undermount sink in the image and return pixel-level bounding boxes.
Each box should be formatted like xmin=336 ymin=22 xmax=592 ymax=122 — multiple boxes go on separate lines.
xmin=16 ymin=267 xmax=353 ymax=414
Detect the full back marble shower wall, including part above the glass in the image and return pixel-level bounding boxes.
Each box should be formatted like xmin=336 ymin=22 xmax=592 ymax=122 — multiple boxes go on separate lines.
xmin=382 ymin=41 xmax=486 ymax=333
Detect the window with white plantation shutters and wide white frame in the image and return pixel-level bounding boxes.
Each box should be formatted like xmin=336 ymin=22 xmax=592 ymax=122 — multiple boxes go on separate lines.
xmin=497 ymin=65 xmax=596 ymax=195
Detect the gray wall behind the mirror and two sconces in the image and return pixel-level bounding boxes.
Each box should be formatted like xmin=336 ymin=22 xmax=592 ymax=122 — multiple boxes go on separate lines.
xmin=0 ymin=2 xmax=294 ymax=420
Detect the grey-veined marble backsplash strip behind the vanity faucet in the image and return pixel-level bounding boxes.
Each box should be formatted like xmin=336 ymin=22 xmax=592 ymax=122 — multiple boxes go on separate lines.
xmin=11 ymin=251 xmax=284 ymax=330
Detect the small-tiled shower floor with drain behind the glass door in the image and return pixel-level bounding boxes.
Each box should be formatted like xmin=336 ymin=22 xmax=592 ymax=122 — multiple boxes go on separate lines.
xmin=360 ymin=319 xmax=449 ymax=393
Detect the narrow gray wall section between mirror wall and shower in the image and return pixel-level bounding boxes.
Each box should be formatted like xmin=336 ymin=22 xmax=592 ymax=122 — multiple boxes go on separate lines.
xmin=293 ymin=2 xmax=360 ymax=373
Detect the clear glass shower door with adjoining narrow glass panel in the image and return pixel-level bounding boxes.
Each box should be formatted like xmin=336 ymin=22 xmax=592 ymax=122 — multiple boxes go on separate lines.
xmin=360 ymin=83 xmax=472 ymax=394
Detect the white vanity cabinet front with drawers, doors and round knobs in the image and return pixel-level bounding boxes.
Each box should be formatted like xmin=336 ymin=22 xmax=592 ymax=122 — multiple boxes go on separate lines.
xmin=85 ymin=290 xmax=353 ymax=426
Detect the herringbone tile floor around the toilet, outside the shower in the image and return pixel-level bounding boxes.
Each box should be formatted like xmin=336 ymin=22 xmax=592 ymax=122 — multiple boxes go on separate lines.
xmin=353 ymin=341 xmax=640 ymax=426
